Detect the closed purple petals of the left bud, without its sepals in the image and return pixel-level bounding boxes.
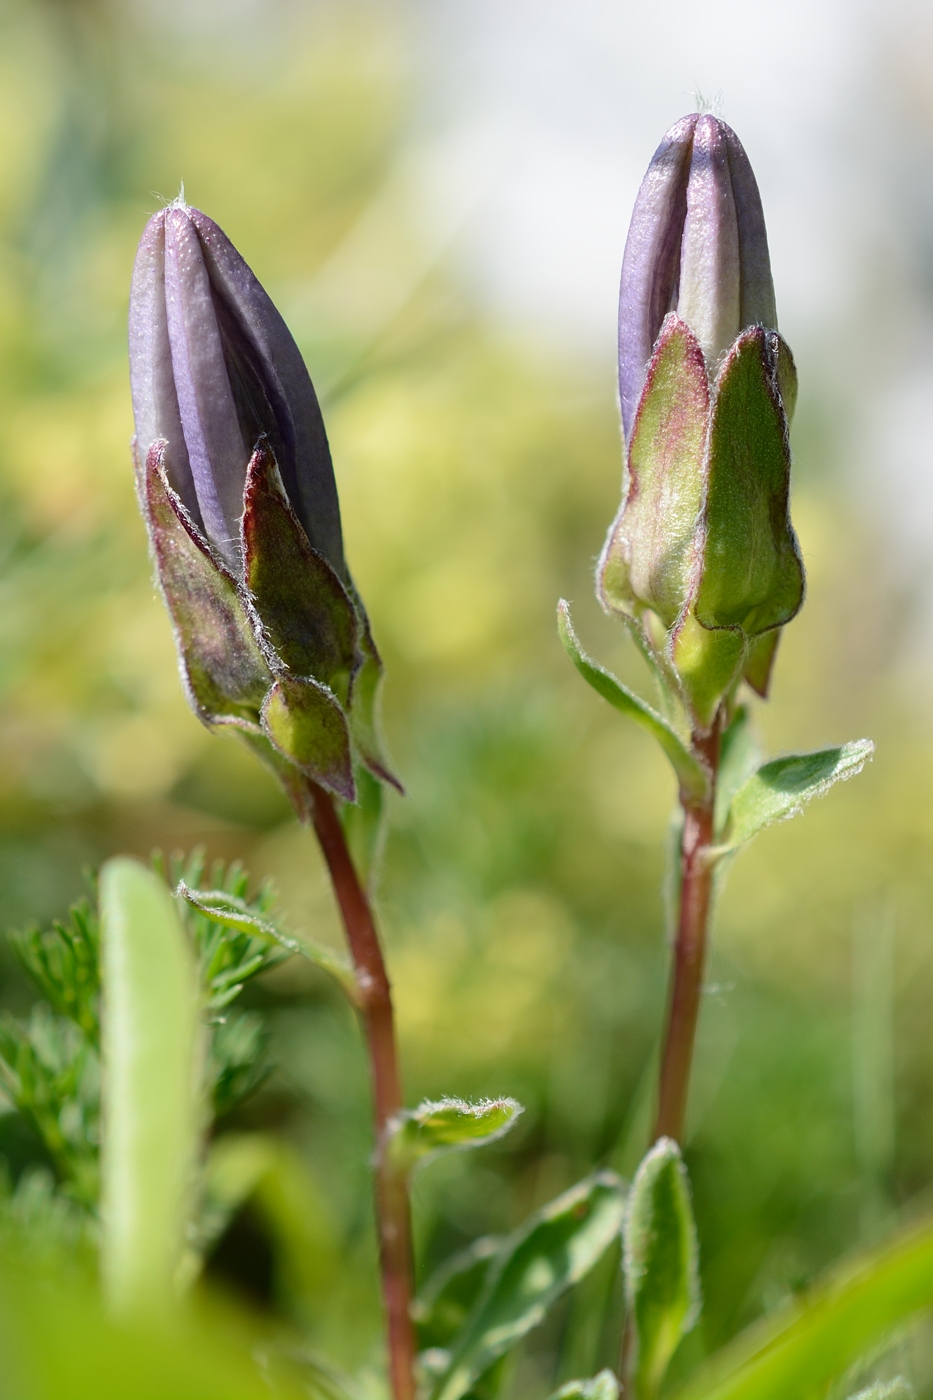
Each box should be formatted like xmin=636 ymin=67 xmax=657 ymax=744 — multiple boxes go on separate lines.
xmin=129 ymin=203 xmax=346 ymax=578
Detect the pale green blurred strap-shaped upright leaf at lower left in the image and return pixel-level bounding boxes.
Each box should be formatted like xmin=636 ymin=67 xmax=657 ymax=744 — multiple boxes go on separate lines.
xmin=99 ymin=857 xmax=202 ymax=1315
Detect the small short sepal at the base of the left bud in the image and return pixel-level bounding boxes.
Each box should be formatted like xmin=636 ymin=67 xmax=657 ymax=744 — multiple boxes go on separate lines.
xmin=261 ymin=676 xmax=356 ymax=802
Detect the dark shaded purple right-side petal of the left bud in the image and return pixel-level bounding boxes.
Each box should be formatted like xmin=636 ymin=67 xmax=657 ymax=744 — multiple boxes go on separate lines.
xmin=189 ymin=209 xmax=346 ymax=578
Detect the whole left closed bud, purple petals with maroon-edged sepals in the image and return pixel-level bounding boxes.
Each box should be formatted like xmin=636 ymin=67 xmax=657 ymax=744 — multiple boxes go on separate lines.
xmin=129 ymin=203 xmax=395 ymax=816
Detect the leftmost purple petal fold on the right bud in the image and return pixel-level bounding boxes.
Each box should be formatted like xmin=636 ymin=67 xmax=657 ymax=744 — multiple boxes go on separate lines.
xmin=619 ymin=112 xmax=700 ymax=442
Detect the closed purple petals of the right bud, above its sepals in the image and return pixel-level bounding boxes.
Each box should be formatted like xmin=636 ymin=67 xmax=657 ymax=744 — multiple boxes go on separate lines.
xmin=619 ymin=112 xmax=778 ymax=442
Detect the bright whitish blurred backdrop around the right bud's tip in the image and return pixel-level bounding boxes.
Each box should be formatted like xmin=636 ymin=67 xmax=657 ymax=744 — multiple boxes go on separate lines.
xmin=400 ymin=0 xmax=933 ymax=602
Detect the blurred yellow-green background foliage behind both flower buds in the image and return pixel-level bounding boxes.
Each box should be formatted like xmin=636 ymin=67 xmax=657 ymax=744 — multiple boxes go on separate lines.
xmin=0 ymin=0 xmax=933 ymax=1394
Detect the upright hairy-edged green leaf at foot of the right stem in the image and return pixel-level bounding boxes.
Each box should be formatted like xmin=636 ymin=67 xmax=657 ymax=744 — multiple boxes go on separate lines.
xmin=623 ymin=1138 xmax=700 ymax=1400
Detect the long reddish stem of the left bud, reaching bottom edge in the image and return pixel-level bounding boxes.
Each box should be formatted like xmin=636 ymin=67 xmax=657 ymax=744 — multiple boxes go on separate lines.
xmin=310 ymin=783 xmax=415 ymax=1400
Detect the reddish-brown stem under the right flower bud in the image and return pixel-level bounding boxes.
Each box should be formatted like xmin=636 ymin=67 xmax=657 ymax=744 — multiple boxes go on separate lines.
xmin=651 ymin=724 xmax=720 ymax=1142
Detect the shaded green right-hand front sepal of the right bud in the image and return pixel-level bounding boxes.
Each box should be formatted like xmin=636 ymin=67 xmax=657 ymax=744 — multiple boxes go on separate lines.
xmin=692 ymin=326 xmax=804 ymax=637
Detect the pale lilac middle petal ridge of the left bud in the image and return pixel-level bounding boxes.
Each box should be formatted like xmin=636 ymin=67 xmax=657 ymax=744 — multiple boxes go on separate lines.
xmin=165 ymin=209 xmax=249 ymax=566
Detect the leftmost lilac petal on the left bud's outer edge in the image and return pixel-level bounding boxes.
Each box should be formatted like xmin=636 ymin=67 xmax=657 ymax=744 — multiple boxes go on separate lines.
xmin=129 ymin=210 xmax=202 ymax=525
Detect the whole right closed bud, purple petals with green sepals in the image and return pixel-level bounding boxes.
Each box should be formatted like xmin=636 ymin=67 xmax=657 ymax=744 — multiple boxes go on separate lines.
xmin=597 ymin=113 xmax=804 ymax=731
